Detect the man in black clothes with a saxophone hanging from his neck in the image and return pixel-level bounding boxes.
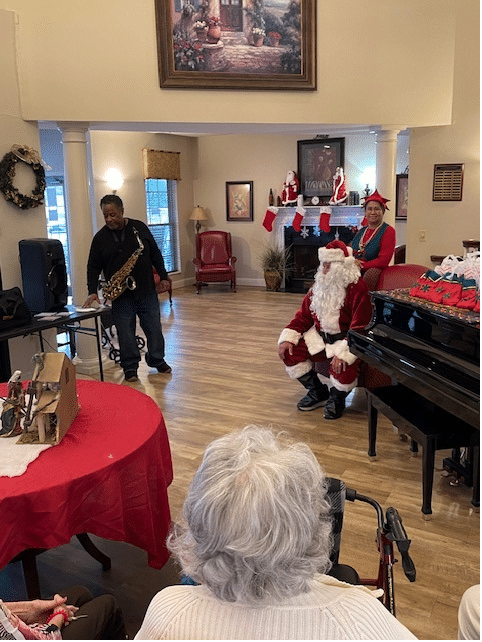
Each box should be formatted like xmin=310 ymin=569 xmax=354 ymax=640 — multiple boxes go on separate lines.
xmin=84 ymin=194 xmax=171 ymax=382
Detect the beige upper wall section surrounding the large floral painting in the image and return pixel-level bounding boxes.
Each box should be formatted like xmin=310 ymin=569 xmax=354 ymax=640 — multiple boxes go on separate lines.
xmin=0 ymin=0 xmax=456 ymax=126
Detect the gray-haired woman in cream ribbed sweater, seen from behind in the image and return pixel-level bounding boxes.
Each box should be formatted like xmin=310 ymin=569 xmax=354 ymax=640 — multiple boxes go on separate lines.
xmin=135 ymin=426 xmax=416 ymax=640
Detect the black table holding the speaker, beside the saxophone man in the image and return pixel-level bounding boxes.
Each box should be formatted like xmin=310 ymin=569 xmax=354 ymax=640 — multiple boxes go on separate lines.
xmin=0 ymin=305 xmax=106 ymax=381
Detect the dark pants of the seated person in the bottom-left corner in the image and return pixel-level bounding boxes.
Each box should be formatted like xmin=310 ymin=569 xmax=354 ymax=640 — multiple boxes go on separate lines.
xmin=60 ymin=586 xmax=126 ymax=640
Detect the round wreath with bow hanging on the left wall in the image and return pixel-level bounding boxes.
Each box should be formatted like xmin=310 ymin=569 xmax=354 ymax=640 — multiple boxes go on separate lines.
xmin=0 ymin=145 xmax=47 ymax=210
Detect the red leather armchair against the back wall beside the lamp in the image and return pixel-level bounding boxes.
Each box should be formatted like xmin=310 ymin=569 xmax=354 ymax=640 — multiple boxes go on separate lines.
xmin=192 ymin=230 xmax=236 ymax=294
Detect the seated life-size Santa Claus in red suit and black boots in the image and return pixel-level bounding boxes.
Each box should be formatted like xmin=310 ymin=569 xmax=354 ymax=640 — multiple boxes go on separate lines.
xmin=278 ymin=240 xmax=372 ymax=419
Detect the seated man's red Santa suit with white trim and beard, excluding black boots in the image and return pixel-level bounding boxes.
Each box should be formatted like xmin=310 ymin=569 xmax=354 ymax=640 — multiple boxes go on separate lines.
xmin=278 ymin=243 xmax=372 ymax=392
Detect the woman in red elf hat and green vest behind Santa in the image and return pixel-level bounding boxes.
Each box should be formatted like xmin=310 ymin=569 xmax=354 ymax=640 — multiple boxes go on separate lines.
xmin=350 ymin=190 xmax=395 ymax=274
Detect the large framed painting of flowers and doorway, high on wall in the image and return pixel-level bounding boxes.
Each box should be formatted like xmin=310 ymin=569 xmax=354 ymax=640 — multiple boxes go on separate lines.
xmin=155 ymin=0 xmax=316 ymax=90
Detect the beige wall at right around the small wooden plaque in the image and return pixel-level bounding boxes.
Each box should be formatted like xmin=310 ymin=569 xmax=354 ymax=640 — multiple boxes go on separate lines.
xmin=407 ymin=0 xmax=480 ymax=266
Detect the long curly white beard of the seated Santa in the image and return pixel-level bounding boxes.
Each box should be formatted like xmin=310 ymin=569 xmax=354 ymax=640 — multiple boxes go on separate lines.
xmin=310 ymin=260 xmax=360 ymax=334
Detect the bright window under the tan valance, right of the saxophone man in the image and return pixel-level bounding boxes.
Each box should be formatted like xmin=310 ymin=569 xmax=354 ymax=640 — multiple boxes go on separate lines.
xmin=145 ymin=178 xmax=181 ymax=272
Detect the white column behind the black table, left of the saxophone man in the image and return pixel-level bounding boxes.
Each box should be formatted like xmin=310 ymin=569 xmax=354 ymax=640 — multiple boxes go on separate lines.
xmin=57 ymin=123 xmax=99 ymax=375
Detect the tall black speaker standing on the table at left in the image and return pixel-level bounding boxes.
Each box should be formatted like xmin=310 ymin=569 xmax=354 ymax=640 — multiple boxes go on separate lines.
xmin=18 ymin=239 xmax=68 ymax=314
